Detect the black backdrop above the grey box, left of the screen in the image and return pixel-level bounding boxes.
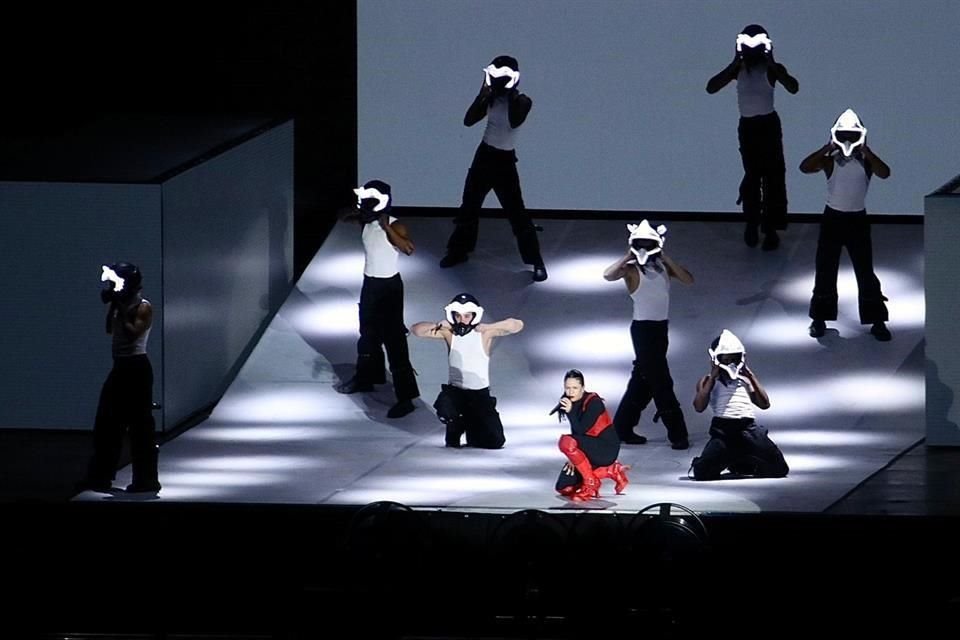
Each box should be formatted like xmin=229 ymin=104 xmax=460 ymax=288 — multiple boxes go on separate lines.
xmin=0 ymin=0 xmax=357 ymax=275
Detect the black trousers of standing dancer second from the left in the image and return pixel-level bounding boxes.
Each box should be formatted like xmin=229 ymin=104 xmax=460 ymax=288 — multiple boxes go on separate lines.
xmin=357 ymin=273 xmax=420 ymax=400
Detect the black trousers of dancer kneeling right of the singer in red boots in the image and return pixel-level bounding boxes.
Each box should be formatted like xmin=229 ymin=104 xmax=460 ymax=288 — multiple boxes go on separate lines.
xmin=692 ymin=418 xmax=790 ymax=480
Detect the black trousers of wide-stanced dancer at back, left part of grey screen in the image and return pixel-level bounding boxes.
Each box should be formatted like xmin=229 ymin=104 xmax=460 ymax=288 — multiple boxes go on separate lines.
xmin=447 ymin=142 xmax=543 ymax=265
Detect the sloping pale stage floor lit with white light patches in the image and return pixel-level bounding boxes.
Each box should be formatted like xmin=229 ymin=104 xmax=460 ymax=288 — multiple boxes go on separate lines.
xmin=78 ymin=218 xmax=924 ymax=512
